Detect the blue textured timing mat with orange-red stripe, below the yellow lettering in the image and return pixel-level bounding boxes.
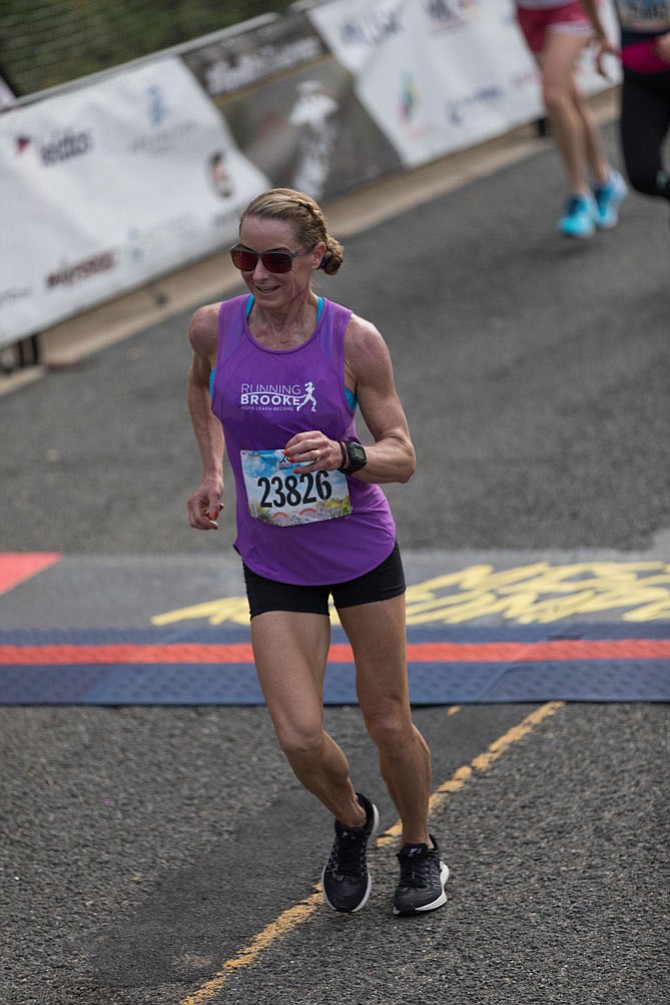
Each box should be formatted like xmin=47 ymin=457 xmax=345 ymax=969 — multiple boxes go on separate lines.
xmin=0 ymin=622 xmax=670 ymax=706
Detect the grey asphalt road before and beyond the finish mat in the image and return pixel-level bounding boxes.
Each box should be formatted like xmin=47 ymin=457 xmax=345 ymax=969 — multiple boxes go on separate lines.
xmin=0 ymin=119 xmax=670 ymax=1005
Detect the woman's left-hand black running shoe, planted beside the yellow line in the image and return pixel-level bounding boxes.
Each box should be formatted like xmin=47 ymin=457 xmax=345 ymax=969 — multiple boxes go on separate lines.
xmin=321 ymin=792 xmax=379 ymax=914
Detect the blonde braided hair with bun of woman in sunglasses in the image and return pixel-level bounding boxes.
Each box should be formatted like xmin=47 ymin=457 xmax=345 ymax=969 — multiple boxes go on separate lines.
xmin=240 ymin=189 xmax=345 ymax=275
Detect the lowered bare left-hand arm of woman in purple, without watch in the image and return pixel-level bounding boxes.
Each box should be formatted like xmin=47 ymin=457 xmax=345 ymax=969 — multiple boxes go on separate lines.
xmin=187 ymin=304 xmax=224 ymax=531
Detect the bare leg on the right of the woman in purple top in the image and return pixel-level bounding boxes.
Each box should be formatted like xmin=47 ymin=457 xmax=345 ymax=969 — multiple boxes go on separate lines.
xmin=340 ymin=596 xmax=432 ymax=847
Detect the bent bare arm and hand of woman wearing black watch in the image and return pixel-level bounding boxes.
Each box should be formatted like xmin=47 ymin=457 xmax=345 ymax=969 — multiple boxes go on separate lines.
xmin=285 ymin=315 xmax=416 ymax=483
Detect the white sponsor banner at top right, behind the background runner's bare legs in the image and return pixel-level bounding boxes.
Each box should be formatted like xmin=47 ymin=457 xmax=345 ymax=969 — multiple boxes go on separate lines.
xmin=308 ymin=0 xmax=612 ymax=167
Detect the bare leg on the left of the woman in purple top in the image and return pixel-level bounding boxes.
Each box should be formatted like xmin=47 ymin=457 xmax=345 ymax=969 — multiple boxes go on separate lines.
xmin=251 ymin=611 xmax=366 ymax=827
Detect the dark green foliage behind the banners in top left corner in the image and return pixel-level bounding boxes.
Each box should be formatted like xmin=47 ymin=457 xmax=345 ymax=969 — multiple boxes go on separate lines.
xmin=0 ymin=0 xmax=290 ymax=94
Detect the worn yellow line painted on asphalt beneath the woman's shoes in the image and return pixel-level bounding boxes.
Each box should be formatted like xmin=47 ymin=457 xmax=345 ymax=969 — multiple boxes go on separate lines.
xmin=181 ymin=701 xmax=566 ymax=1005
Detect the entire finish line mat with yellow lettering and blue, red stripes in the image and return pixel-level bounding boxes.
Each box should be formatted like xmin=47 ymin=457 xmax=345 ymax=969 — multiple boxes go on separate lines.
xmin=0 ymin=553 xmax=670 ymax=706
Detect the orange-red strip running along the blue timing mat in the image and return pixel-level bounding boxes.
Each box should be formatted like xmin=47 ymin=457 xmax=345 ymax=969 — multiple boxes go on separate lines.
xmin=0 ymin=643 xmax=670 ymax=666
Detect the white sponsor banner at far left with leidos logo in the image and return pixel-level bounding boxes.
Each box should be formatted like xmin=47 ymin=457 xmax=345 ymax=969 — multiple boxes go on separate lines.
xmin=0 ymin=58 xmax=270 ymax=346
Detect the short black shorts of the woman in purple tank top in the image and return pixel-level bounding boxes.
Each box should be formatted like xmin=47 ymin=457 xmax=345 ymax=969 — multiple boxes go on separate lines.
xmin=243 ymin=544 xmax=405 ymax=618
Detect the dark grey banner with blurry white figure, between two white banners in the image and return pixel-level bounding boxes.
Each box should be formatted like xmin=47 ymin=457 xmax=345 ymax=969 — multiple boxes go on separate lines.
xmin=183 ymin=14 xmax=401 ymax=200
